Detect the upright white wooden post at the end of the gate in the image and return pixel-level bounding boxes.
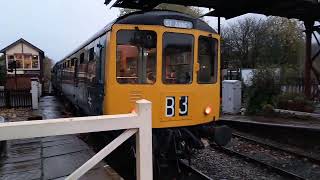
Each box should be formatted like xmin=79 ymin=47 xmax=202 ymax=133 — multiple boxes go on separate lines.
xmin=136 ymin=100 xmax=153 ymax=180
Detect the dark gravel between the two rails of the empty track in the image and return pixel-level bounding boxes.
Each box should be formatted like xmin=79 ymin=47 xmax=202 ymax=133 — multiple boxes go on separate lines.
xmin=228 ymin=138 xmax=320 ymax=180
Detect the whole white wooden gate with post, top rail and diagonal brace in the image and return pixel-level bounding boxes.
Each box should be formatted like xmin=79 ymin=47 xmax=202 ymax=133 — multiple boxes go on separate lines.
xmin=0 ymin=100 xmax=153 ymax=180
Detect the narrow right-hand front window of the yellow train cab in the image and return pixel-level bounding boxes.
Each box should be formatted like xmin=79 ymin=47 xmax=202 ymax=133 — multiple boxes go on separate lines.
xmin=198 ymin=36 xmax=218 ymax=84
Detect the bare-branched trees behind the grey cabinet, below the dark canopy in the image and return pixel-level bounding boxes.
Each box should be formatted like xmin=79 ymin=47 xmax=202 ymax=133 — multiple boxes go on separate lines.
xmin=222 ymin=17 xmax=304 ymax=68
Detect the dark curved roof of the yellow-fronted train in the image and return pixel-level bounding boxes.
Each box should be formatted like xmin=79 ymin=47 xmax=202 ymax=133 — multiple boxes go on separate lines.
xmin=57 ymin=10 xmax=216 ymax=64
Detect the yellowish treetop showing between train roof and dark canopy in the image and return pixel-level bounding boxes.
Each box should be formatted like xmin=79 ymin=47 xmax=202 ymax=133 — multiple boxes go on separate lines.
xmin=120 ymin=3 xmax=202 ymax=18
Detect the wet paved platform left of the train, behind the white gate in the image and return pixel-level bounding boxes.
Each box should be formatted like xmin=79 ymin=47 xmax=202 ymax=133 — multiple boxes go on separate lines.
xmin=0 ymin=96 xmax=122 ymax=180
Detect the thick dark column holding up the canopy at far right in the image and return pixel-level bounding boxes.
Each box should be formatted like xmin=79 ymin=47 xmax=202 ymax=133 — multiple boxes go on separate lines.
xmin=304 ymin=20 xmax=314 ymax=98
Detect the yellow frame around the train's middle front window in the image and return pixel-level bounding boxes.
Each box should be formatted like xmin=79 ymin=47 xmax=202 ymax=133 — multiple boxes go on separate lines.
xmin=161 ymin=31 xmax=196 ymax=85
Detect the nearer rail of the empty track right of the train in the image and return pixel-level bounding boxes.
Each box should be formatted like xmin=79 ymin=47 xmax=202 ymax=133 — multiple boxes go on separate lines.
xmin=211 ymin=145 xmax=306 ymax=180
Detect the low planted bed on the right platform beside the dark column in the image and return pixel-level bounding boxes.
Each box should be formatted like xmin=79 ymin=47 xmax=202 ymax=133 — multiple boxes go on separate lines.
xmin=276 ymin=93 xmax=315 ymax=112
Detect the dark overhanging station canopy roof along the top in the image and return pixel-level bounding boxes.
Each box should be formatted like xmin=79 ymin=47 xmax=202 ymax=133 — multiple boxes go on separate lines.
xmin=105 ymin=0 xmax=320 ymax=21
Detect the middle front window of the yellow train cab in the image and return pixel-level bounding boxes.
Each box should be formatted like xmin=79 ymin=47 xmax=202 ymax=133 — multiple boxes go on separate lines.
xmin=162 ymin=33 xmax=194 ymax=84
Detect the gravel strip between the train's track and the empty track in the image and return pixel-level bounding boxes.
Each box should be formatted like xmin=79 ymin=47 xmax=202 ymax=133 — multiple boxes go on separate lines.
xmin=192 ymin=148 xmax=286 ymax=180
